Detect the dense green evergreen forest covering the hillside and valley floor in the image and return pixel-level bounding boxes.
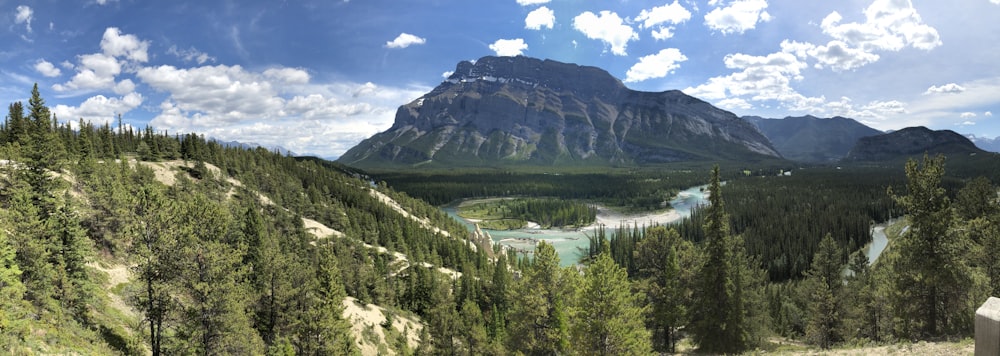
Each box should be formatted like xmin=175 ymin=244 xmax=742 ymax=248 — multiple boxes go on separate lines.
xmin=0 ymin=86 xmax=1000 ymax=355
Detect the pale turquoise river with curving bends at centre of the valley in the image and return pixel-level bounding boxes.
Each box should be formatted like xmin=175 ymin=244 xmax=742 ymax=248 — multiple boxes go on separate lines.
xmin=442 ymin=185 xmax=707 ymax=266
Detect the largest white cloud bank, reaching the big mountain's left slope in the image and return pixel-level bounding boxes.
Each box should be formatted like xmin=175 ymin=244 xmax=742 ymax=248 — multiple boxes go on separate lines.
xmin=136 ymin=65 xmax=430 ymax=158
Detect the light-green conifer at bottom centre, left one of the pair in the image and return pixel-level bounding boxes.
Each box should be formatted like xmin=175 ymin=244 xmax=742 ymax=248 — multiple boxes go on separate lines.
xmin=507 ymin=241 xmax=570 ymax=355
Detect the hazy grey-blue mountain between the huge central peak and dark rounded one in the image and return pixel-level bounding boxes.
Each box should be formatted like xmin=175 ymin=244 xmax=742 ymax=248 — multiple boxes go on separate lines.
xmin=743 ymin=116 xmax=882 ymax=163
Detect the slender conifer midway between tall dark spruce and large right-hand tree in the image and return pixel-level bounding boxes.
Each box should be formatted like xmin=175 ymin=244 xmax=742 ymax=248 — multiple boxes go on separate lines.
xmin=805 ymin=234 xmax=844 ymax=349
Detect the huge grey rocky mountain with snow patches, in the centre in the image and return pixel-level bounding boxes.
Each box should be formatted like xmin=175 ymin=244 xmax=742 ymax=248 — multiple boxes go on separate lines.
xmin=338 ymin=56 xmax=780 ymax=168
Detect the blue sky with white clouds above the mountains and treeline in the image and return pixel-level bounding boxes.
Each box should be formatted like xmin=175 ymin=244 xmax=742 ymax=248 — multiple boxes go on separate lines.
xmin=0 ymin=0 xmax=1000 ymax=158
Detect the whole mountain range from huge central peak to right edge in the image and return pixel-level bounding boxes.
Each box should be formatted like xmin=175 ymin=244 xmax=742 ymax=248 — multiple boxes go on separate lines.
xmin=338 ymin=56 xmax=1000 ymax=169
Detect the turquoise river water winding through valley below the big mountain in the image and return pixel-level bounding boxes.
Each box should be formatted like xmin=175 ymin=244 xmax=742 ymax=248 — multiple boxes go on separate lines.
xmin=442 ymin=185 xmax=707 ymax=266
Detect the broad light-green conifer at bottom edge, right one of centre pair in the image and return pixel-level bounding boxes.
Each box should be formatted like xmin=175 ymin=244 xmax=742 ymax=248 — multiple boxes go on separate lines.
xmin=573 ymin=241 xmax=653 ymax=355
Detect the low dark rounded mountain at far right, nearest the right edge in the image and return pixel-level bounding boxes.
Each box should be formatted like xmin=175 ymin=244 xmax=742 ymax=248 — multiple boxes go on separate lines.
xmin=844 ymin=126 xmax=986 ymax=161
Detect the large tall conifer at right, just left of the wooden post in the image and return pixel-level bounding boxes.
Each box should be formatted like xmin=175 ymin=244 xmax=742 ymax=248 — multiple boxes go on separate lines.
xmin=889 ymin=155 xmax=972 ymax=338
